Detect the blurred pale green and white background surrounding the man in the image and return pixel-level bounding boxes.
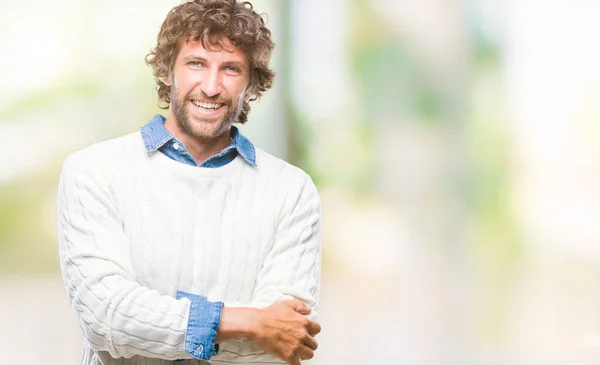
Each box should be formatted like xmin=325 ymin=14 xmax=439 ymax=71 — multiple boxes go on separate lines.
xmin=0 ymin=0 xmax=600 ymax=365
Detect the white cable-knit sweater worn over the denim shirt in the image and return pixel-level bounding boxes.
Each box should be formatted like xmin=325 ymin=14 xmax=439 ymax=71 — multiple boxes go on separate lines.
xmin=58 ymin=133 xmax=321 ymax=365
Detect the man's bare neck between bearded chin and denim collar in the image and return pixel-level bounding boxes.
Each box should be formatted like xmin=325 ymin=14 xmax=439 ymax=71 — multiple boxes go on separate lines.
xmin=165 ymin=112 xmax=231 ymax=164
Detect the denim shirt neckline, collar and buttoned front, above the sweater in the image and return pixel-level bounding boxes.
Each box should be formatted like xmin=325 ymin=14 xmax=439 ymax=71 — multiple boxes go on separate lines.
xmin=140 ymin=114 xmax=256 ymax=168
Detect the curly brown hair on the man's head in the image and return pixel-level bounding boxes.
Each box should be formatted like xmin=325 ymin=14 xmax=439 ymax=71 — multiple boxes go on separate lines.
xmin=146 ymin=0 xmax=275 ymax=124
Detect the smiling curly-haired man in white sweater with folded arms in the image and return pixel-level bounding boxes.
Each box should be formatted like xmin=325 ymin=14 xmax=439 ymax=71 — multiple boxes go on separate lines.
xmin=58 ymin=0 xmax=321 ymax=365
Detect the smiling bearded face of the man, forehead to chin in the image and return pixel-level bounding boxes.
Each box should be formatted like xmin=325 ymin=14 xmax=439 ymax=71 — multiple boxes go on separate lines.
xmin=167 ymin=38 xmax=250 ymax=140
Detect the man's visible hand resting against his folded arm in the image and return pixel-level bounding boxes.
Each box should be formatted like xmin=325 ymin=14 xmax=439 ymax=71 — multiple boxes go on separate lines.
xmin=252 ymin=299 xmax=321 ymax=365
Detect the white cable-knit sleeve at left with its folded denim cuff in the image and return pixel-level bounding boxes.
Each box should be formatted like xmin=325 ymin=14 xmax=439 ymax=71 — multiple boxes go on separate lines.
xmin=58 ymin=154 xmax=222 ymax=360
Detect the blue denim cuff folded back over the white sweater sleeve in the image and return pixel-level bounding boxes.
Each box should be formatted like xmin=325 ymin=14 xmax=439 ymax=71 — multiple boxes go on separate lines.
xmin=176 ymin=291 xmax=223 ymax=360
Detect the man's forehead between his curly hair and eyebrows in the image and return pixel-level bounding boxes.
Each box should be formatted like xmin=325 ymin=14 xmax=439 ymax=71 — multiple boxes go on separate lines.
xmin=177 ymin=37 xmax=249 ymax=64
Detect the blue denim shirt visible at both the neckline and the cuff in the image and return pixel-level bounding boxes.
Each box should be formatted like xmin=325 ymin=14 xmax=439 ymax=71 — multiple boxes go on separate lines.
xmin=140 ymin=114 xmax=256 ymax=363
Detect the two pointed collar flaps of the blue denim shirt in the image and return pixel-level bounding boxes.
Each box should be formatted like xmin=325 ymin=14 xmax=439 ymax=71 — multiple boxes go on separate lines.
xmin=140 ymin=114 xmax=256 ymax=167
